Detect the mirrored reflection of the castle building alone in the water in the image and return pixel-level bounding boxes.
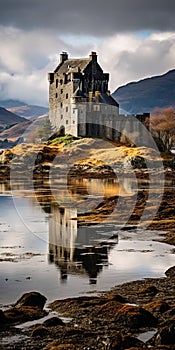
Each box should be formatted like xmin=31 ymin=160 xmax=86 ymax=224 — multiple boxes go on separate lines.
xmin=49 ymin=204 xmax=117 ymax=284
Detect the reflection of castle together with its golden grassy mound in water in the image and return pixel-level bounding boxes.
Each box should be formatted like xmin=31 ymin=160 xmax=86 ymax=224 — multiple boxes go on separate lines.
xmin=32 ymin=177 xmax=140 ymax=284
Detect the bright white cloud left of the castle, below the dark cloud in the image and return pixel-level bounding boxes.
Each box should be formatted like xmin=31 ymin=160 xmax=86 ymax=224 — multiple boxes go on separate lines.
xmin=0 ymin=26 xmax=67 ymax=105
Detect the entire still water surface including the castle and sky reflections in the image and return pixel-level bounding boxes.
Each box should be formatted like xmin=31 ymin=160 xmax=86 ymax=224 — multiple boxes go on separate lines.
xmin=0 ymin=179 xmax=175 ymax=305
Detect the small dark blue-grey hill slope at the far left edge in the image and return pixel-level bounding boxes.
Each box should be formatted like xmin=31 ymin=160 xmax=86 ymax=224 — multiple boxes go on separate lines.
xmin=0 ymin=107 xmax=26 ymax=130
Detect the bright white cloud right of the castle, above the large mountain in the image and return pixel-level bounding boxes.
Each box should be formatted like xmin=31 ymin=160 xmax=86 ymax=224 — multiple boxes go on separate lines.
xmin=99 ymin=32 xmax=175 ymax=91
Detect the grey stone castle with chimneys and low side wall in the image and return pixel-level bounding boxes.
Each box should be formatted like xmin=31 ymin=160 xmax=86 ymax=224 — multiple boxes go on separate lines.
xmin=48 ymin=52 xmax=149 ymax=142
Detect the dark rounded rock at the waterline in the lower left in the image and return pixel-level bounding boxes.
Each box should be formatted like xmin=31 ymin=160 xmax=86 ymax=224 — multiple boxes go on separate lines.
xmin=15 ymin=292 xmax=47 ymax=309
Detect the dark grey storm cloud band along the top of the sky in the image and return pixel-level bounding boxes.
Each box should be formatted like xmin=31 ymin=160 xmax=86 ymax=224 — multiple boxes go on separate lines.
xmin=0 ymin=0 xmax=175 ymax=36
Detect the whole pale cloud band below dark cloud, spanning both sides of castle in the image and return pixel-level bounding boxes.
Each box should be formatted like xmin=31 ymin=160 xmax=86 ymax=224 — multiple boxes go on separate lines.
xmin=0 ymin=26 xmax=175 ymax=105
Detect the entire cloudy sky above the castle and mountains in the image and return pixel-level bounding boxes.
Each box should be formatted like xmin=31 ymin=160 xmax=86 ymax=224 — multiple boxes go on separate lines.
xmin=0 ymin=0 xmax=175 ymax=106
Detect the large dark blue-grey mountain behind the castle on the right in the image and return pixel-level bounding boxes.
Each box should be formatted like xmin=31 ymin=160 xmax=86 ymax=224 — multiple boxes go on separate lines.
xmin=112 ymin=69 xmax=175 ymax=114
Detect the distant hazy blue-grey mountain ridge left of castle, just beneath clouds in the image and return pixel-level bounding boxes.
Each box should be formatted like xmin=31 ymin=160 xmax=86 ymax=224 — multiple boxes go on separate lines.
xmin=0 ymin=100 xmax=49 ymax=120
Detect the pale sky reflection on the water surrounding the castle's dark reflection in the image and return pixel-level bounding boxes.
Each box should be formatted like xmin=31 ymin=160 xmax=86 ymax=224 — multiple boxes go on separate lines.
xmin=0 ymin=196 xmax=175 ymax=303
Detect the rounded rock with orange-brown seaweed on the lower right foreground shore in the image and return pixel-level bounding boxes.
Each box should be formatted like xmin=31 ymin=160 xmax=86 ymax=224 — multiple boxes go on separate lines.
xmin=115 ymin=305 xmax=157 ymax=330
